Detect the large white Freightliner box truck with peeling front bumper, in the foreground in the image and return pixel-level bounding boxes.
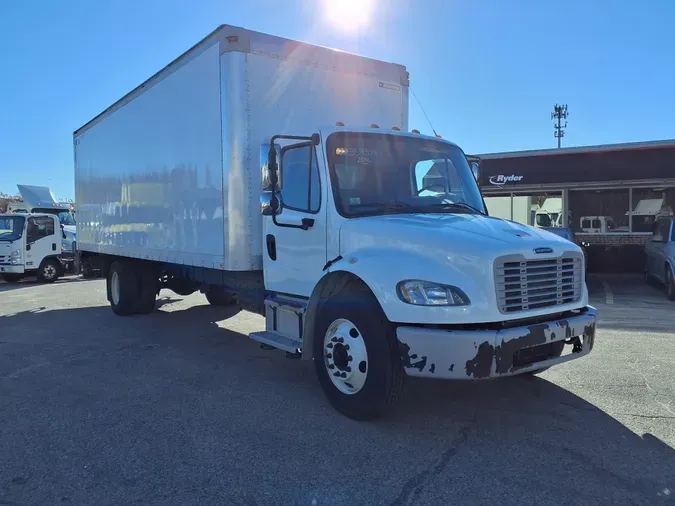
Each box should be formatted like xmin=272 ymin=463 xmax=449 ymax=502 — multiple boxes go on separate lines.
xmin=74 ymin=26 xmax=596 ymax=419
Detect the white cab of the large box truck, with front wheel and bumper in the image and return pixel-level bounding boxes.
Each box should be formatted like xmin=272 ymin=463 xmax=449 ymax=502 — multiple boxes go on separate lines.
xmin=251 ymin=126 xmax=595 ymax=418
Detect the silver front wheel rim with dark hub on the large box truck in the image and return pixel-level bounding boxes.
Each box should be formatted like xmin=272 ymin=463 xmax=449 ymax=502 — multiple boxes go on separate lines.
xmin=323 ymin=318 xmax=368 ymax=395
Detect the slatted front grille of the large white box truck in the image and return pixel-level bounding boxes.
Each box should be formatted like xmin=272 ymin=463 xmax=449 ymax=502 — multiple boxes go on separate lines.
xmin=495 ymin=253 xmax=584 ymax=313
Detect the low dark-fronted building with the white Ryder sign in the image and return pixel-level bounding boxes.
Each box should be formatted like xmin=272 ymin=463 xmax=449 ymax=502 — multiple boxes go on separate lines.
xmin=476 ymin=140 xmax=675 ymax=272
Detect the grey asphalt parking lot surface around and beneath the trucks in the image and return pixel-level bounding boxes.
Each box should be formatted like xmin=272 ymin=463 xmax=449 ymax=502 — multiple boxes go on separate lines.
xmin=0 ymin=277 xmax=675 ymax=505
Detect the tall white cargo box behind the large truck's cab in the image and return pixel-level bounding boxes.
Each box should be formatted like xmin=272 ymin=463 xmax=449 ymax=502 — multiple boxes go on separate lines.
xmin=73 ymin=25 xmax=408 ymax=271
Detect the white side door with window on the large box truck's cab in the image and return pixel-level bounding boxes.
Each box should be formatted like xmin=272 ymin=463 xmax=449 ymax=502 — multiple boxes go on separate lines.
xmin=263 ymin=142 xmax=327 ymax=297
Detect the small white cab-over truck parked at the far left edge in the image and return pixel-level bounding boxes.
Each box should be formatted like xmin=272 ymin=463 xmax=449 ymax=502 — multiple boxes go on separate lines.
xmin=0 ymin=213 xmax=63 ymax=283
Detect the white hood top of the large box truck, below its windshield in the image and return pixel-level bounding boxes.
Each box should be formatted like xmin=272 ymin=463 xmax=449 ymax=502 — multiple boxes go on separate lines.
xmin=340 ymin=214 xmax=578 ymax=260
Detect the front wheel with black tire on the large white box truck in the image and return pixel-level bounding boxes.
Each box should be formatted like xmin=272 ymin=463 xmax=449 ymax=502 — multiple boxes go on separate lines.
xmin=312 ymin=282 xmax=405 ymax=420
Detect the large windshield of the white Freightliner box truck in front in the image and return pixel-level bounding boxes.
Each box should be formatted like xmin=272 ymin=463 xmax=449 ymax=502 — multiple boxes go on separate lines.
xmin=326 ymin=132 xmax=485 ymax=217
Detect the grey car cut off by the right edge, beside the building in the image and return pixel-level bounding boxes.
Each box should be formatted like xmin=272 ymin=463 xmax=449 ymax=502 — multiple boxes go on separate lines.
xmin=645 ymin=216 xmax=675 ymax=300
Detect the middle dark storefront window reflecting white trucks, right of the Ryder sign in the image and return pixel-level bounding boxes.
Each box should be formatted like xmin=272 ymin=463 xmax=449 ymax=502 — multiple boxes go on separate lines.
xmin=569 ymin=188 xmax=630 ymax=234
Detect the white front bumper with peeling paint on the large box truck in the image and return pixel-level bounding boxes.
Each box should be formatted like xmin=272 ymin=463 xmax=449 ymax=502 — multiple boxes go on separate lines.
xmin=396 ymin=306 xmax=597 ymax=379
